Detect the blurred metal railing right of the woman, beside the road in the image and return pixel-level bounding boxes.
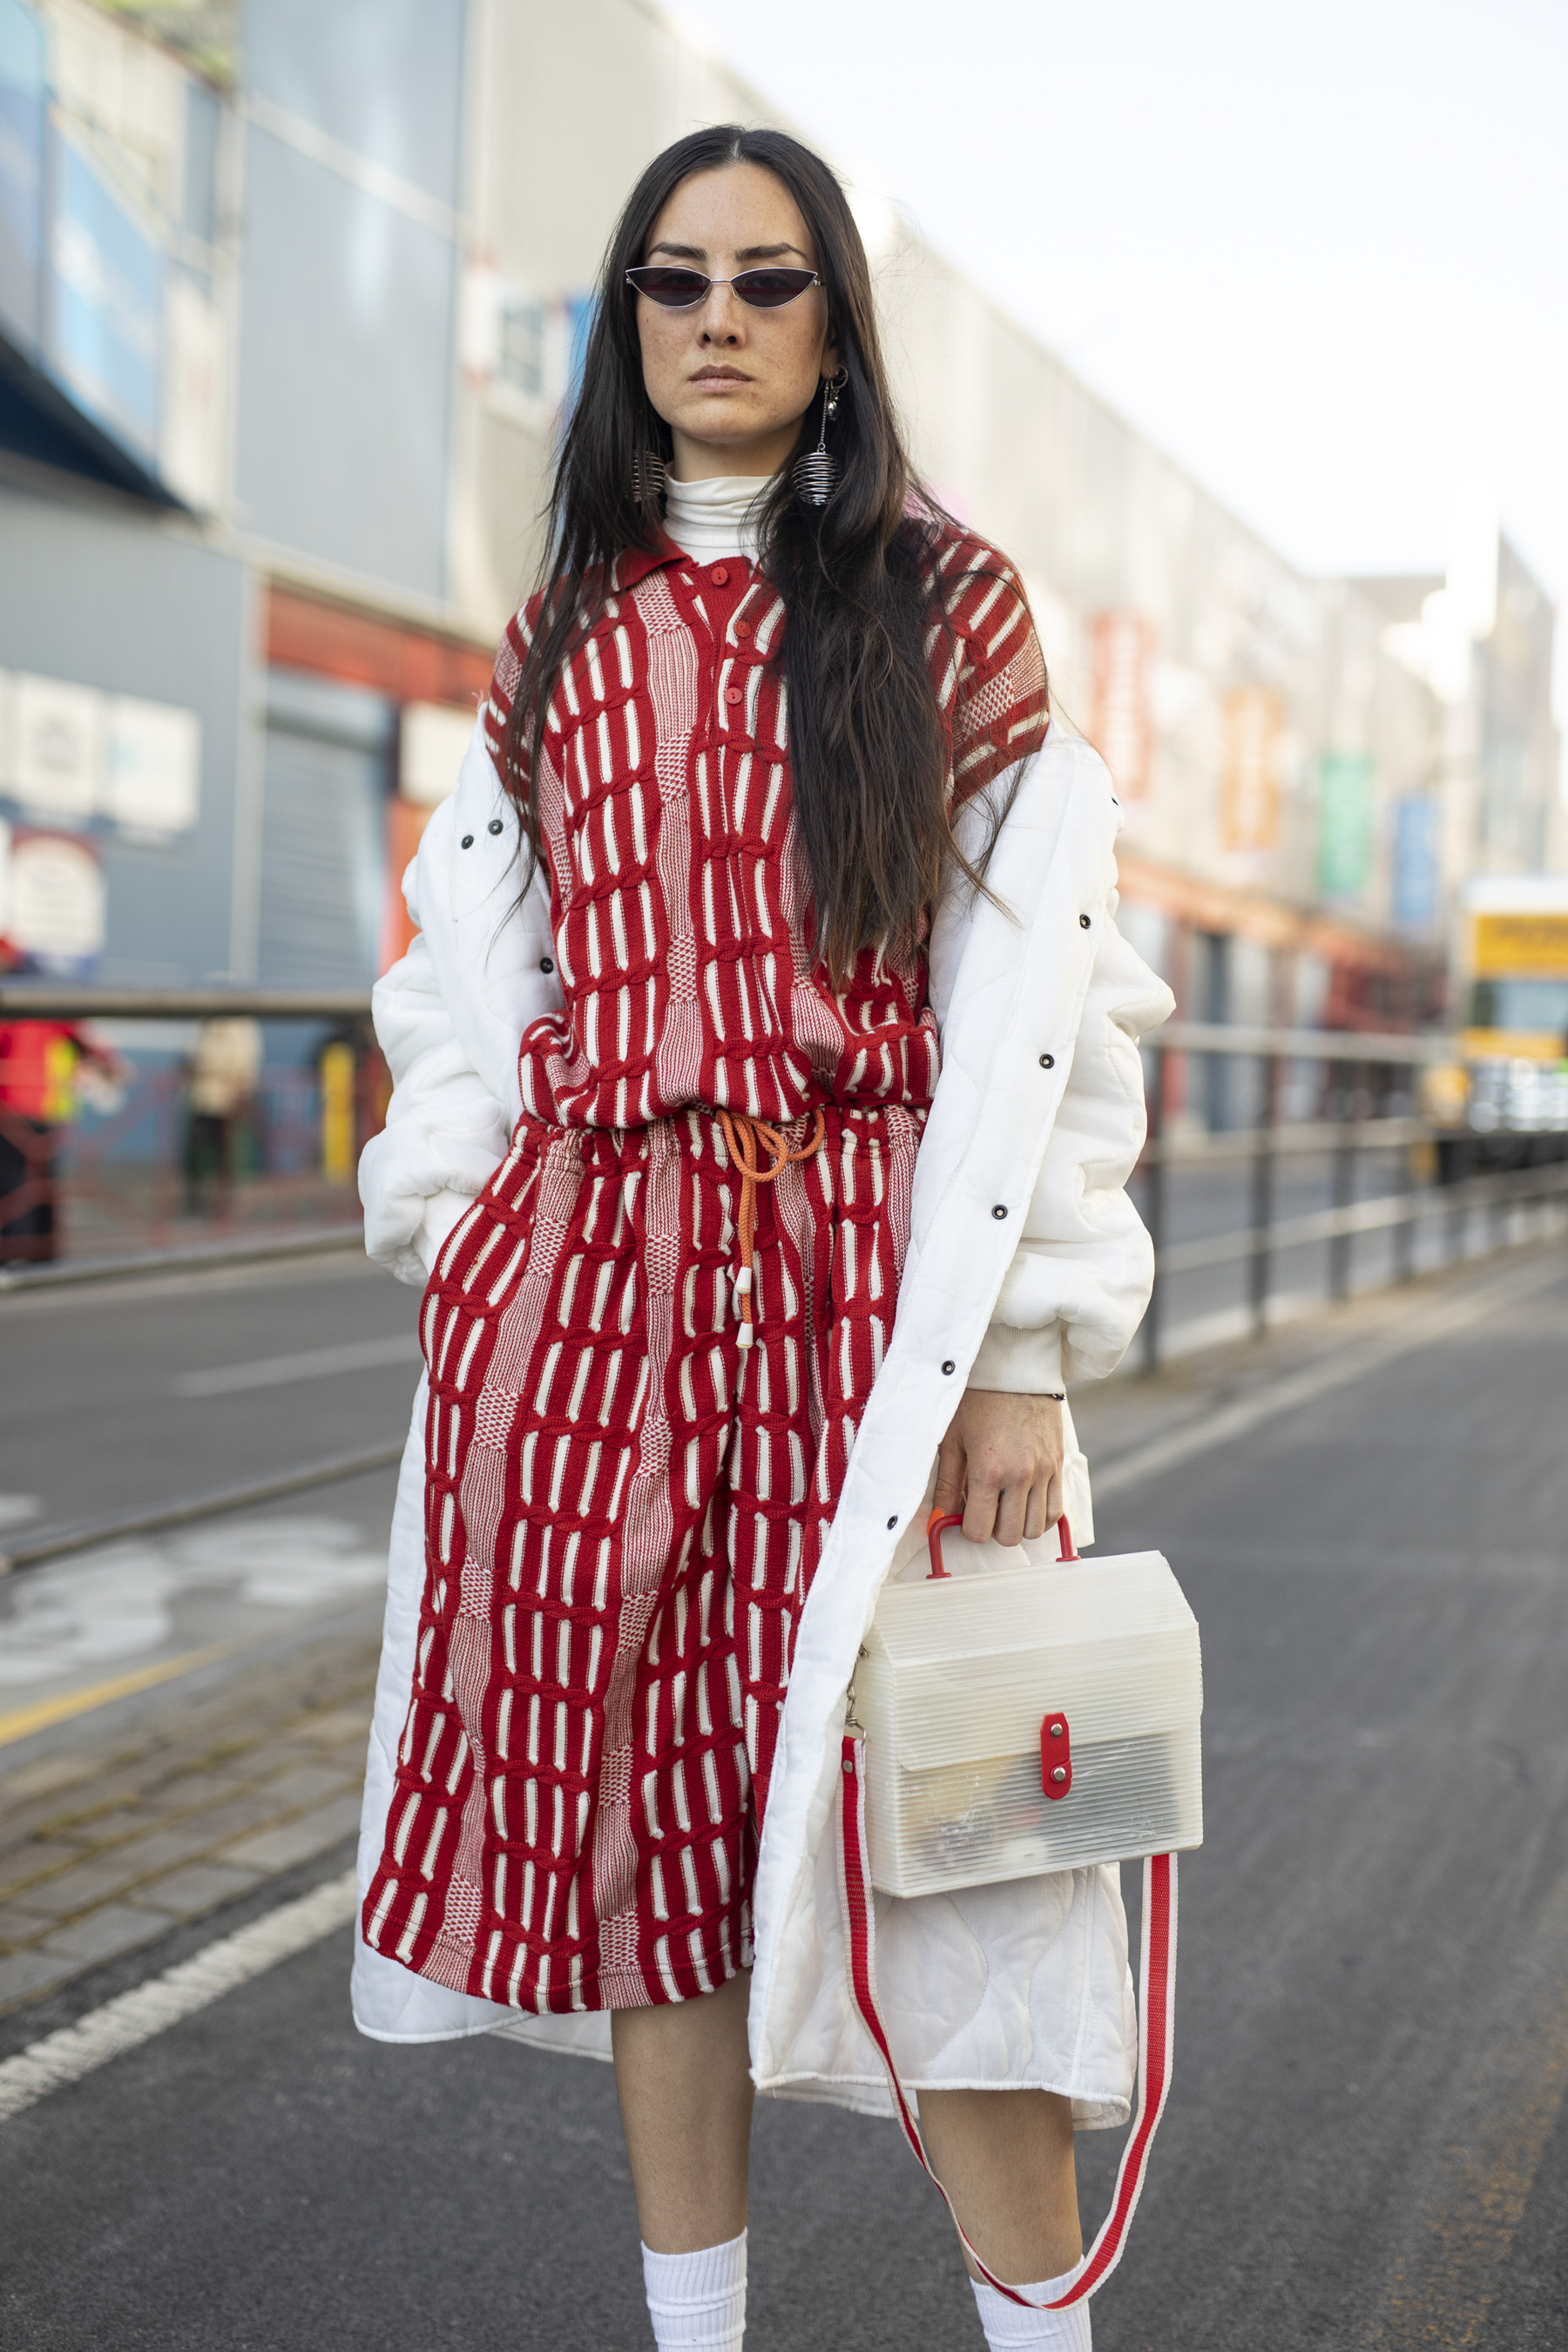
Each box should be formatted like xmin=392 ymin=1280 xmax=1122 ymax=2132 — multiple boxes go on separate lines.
xmin=1138 ymin=1021 xmax=1568 ymax=1369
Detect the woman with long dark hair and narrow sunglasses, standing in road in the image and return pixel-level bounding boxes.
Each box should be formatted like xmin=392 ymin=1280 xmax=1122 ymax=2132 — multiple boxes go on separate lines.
xmin=355 ymin=127 xmax=1171 ymax=2345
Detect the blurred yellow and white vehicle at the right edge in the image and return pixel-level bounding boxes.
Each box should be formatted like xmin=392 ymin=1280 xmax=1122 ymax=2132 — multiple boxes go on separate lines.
xmin=1423 ymin=875 xmax=1568 ymax=1183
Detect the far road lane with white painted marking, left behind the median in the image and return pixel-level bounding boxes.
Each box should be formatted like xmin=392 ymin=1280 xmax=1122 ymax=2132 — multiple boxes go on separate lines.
xmin=0 ymin=1256 xmax=418 ymax=1734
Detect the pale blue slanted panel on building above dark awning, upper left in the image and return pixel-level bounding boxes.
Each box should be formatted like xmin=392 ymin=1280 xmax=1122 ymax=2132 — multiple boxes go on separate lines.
xmin=50 ymin=134 xmax=162 ymax=466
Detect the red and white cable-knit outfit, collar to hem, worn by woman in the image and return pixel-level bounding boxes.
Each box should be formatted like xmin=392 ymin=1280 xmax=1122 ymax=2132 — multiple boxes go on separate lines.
xmin=362 ymin=486 xmax=1046 ymax=2011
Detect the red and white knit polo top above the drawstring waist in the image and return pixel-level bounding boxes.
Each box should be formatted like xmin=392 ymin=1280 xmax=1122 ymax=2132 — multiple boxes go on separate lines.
xmin=487 ymin=537 xmax=1046 ymax=1126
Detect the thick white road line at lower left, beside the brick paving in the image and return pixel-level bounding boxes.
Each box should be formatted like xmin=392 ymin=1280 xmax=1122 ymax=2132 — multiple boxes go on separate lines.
xmin=0 ymin=1870 xmax=355 ymax=2124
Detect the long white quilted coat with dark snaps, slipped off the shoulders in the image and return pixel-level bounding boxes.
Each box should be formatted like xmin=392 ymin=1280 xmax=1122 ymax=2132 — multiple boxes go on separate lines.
xmin=353 ymin=706 xmax=1173 ymax=2124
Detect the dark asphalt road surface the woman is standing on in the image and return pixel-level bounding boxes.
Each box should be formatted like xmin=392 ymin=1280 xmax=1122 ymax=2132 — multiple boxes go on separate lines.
xmin=0 ymin=1254 xmax=1568 ymax=2352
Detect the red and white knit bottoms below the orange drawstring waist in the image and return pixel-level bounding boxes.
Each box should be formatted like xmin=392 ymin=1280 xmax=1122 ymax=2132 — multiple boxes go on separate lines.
xmin=364 ymin=1105 xmax=924 ymax=2011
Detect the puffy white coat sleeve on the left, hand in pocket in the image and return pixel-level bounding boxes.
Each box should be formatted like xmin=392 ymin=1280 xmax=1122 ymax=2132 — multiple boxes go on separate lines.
xmin=360 ymin=859 xmax=508 ymax=1284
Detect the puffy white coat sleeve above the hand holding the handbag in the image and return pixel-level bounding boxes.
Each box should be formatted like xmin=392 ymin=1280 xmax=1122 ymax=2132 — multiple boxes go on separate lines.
xmin=969 ymin=894 xmax=1175 ymax=1395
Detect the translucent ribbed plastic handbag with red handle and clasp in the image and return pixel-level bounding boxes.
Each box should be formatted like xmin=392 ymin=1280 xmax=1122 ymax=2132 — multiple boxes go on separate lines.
xmin=855 ymin=1512 xmax=1204 ymax=1896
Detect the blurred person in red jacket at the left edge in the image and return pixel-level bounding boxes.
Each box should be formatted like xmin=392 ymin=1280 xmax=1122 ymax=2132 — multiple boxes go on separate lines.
xmin=0 ymin=1021 xmax=125 ymax=1263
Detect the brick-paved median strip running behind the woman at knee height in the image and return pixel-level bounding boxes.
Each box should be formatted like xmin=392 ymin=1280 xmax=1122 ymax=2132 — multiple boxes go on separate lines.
xmin=0 ymin=1244 xmax=1564 ymax=2039
